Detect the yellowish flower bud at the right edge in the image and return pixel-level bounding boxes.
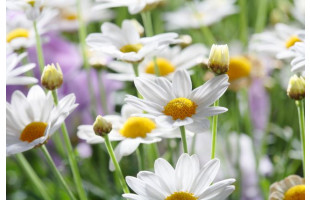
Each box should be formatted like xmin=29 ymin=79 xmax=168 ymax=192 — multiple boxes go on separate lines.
xmin=287 ymin=75 xmax=305 ymax=100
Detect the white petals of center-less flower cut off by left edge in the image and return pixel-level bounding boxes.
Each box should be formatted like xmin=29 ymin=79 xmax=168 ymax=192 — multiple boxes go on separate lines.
xmin=6 ymin=53 xmax=38 ymax=85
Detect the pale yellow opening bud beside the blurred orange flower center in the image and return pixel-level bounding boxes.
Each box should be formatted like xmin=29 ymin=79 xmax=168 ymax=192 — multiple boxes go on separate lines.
xmin=208 ymin=44 xmax=229 ymax=75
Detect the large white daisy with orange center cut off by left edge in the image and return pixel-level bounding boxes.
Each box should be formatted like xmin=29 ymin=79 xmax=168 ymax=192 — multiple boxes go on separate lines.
xmin=6 ymin=85 xmax=77 ymax=156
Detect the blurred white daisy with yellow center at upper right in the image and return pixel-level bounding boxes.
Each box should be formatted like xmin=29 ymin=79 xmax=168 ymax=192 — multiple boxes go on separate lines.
xmin=249 ymin=23 xmax=305 ymax=59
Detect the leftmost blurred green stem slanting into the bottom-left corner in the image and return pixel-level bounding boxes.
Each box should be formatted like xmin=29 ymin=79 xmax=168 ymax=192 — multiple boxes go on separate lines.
xmin=16 ymin=153 xmax=51 ymax=200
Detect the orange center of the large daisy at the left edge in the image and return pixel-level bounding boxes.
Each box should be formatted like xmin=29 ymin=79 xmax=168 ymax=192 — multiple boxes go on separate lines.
xmin=19 ymin=122 xmax=47 ymax=143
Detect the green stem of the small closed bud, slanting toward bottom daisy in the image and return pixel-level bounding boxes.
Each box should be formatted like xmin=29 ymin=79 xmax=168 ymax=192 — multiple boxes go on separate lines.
xmin=103 ymin=134 xmax=129 ymax=193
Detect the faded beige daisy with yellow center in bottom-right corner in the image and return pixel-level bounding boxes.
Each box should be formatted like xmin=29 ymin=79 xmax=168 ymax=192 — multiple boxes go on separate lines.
xmin=269 ymin=175 xmax=305 ymax=200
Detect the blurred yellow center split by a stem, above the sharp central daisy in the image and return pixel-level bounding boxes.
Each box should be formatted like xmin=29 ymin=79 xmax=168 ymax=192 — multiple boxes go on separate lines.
xmin=145 ymin=58 xmax=175 ymax=76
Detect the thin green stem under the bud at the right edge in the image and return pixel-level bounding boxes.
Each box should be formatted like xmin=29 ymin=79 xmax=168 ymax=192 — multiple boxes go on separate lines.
xmin=295 ymin=100 xmax=305 ymax=173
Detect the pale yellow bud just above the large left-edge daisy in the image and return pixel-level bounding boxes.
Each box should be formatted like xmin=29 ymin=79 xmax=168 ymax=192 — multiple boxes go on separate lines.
xmin=41 ymin=63 xmax=63 ymax=90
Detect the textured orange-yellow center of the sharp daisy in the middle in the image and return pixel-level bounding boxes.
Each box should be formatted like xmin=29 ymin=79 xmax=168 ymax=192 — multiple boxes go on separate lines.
xmin=163 ymin=97 xmax=197 ymax=120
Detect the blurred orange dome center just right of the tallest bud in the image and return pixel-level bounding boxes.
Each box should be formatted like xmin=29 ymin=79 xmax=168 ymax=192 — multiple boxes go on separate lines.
xmin=227 ymin=56 xmax=251 ymax=81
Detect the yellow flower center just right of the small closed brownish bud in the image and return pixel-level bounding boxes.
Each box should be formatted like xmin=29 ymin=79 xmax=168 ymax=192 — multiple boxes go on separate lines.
xmin=120 ymin=117 xmax=156 ymax=138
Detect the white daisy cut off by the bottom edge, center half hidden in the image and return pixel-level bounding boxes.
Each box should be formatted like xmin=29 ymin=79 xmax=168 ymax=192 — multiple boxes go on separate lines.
xmin=123 ymin=154 xmax=235 ymax=200
